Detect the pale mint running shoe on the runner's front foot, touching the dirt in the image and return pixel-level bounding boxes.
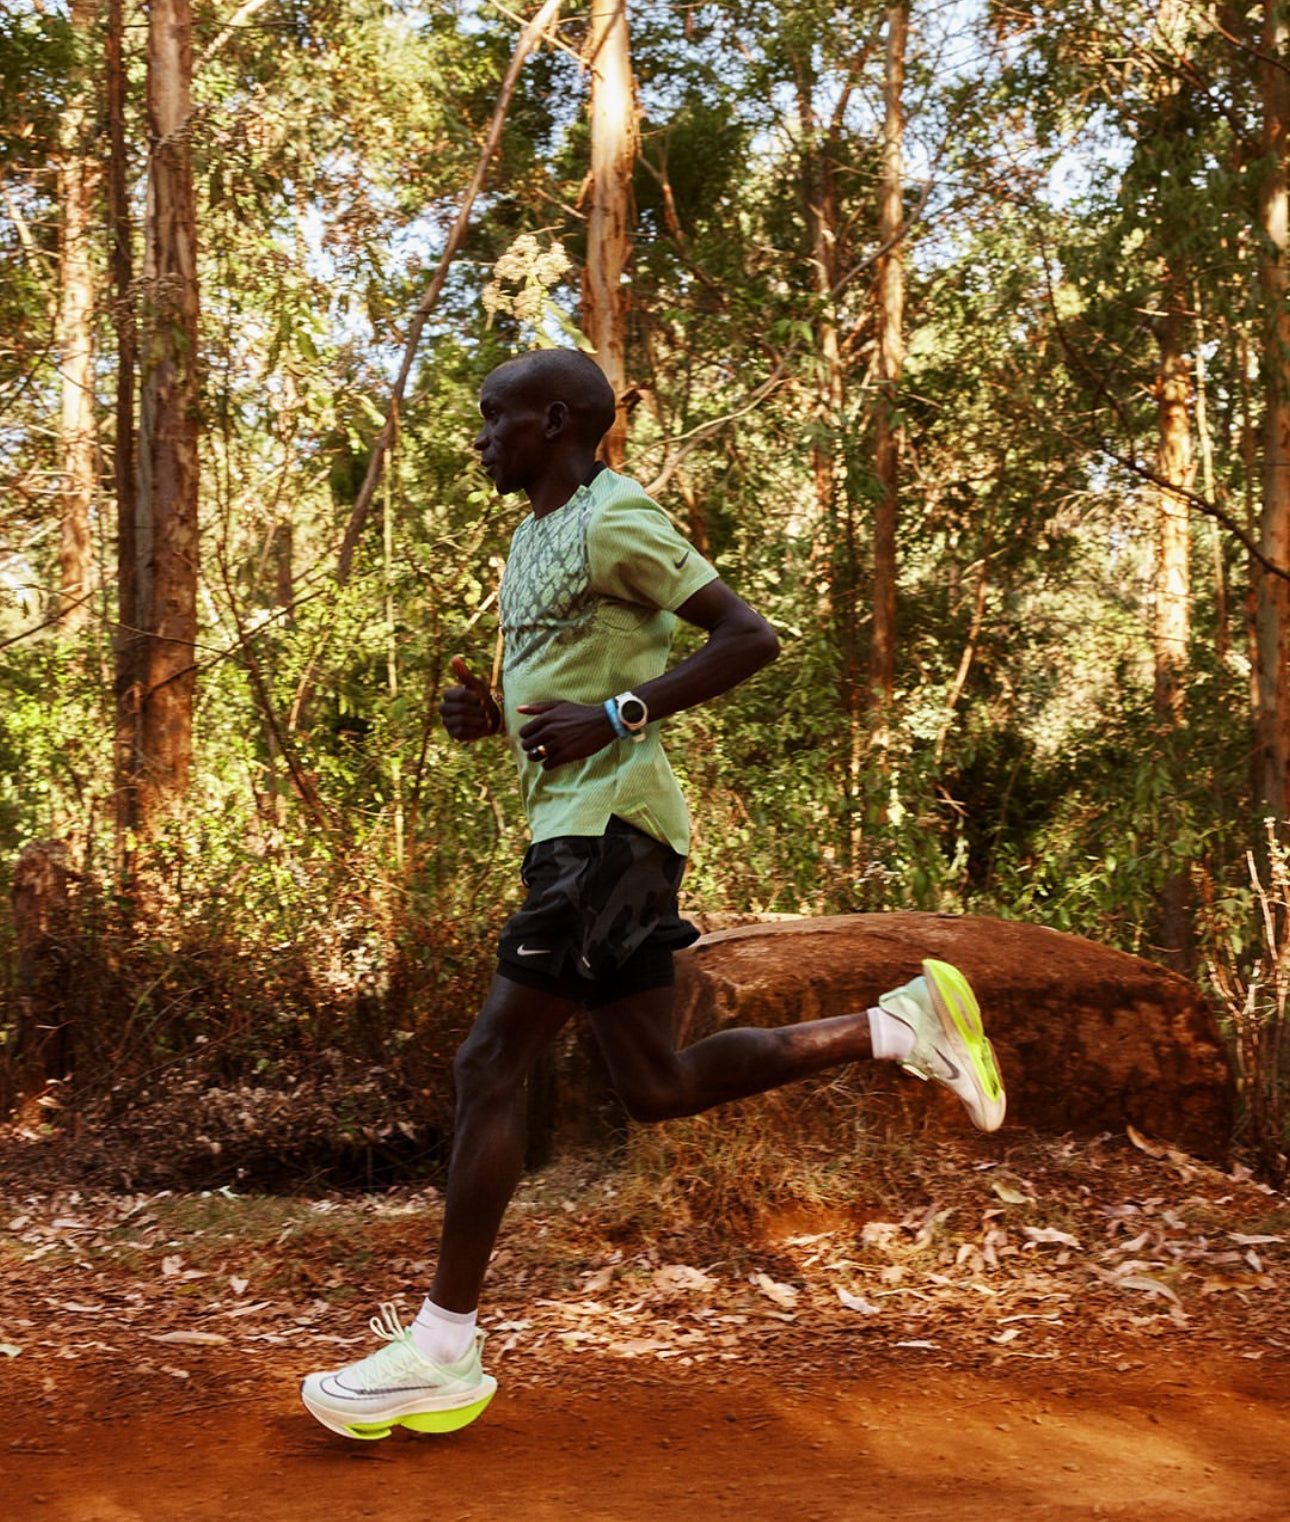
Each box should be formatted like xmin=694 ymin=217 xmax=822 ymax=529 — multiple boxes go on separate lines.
xmin=300 ymin=1304 xmax=497 ymax=1441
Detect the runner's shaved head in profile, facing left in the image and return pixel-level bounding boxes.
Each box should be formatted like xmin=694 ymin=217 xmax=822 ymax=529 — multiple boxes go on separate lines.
xmin=475 ymin=349 xmax=615 ymax=496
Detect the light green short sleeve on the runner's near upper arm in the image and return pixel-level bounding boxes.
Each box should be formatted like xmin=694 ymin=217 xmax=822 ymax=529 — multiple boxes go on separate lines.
xmin=587 ymin=493 xmax=716 ymax=613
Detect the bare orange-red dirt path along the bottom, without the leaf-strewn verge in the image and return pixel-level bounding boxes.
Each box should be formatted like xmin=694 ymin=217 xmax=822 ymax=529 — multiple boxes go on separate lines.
xmin=0 ymin=1348 xmax=1290 ymax=1522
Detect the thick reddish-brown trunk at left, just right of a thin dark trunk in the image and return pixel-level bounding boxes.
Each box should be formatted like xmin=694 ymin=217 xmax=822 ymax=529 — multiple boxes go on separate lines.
xmin=135 ymin=0 xmax=199 ymax=834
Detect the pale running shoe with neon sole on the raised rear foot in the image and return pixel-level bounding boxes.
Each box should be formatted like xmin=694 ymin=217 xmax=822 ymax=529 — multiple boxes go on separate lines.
xmin=878 ymin=960 xmax=1007 ymax=1131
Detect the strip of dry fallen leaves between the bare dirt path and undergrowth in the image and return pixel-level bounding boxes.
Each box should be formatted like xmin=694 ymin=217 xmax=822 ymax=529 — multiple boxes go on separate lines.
xmin=0 ymin=1134 xmax=1290 ymax=1383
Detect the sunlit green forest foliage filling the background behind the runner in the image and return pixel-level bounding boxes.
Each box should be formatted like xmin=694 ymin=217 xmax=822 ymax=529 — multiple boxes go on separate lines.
xmin=0 ymin=0 xmax=1283 ymax=1174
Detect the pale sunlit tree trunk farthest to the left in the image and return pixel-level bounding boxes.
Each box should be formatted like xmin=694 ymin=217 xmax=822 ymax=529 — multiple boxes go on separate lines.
xmin=58 ymin=0 xmax=97 ymax=635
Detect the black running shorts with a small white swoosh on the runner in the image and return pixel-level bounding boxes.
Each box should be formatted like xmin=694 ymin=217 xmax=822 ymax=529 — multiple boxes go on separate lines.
xmin=497 ymin=817 xmax=698 ymax=1009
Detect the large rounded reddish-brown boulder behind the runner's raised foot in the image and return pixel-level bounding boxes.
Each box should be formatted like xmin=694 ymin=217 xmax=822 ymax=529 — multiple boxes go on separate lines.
xmin=677 ymin=913 xmax=1234 ymax=1158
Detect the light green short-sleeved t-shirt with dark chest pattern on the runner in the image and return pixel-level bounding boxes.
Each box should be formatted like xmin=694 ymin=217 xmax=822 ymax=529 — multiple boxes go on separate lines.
xmin=499 ymin=470 xmax=716 ymax=855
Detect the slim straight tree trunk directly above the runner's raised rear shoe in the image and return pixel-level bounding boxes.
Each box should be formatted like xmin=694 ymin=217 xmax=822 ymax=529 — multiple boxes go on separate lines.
xmin=869 ymin=5 xmax=910 ymax=733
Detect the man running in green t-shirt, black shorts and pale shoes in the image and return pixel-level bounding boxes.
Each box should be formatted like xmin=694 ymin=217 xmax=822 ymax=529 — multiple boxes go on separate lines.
xmin=301 ymin=350 xmax=1004 ymax=1438
